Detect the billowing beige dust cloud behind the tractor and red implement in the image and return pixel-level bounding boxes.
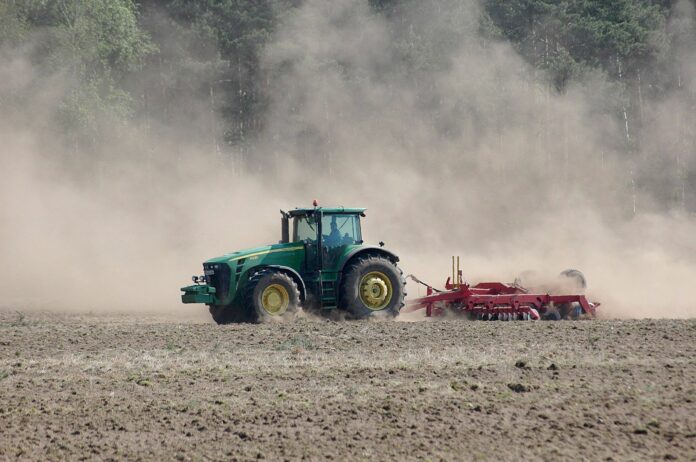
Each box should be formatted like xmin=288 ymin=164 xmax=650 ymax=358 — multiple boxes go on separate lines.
xmin=0 ymin=0 xmax=696 ymax=317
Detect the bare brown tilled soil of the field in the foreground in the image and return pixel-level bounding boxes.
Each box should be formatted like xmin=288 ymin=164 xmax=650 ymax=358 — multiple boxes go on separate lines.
xmin=0 ymin=309 xmax=696 ymax=460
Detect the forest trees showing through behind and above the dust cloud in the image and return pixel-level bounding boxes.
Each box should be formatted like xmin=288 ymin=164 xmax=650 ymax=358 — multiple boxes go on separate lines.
xmin=0 ymin=0 xmax=696 ymax=211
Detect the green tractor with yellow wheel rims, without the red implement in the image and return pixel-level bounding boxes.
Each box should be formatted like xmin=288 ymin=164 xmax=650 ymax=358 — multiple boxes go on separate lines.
xmin=181 ymin=202 xmax=406 ymax=324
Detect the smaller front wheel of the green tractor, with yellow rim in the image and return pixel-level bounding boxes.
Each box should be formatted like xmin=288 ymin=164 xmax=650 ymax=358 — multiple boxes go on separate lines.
xmin=244 ymin=269 xmax=300 ymax=322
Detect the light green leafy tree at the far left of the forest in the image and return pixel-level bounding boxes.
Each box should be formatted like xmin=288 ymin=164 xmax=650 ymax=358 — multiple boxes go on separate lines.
xmin=0 ymin=0 xmax=156 ymax=140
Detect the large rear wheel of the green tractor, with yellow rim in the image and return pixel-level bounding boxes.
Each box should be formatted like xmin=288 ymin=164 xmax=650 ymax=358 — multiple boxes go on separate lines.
xmin=340 ymin=255 xmax=406 ymax=319
